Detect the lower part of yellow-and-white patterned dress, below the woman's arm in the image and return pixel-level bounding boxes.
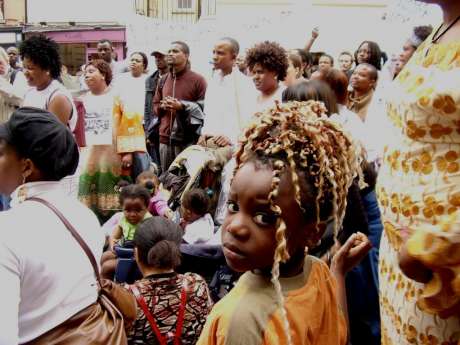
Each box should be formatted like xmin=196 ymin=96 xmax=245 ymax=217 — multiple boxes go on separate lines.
xmin=379 ymin=221 xmax=460 ymax=345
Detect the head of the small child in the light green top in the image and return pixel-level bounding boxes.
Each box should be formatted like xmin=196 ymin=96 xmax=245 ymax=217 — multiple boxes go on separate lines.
xmin=120 ymin=184 xmax=150 ymax=225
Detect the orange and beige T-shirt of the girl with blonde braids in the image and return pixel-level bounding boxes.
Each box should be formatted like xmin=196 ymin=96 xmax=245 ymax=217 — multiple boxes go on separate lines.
xmin=197 ymin=256 xmax=347 ymax=345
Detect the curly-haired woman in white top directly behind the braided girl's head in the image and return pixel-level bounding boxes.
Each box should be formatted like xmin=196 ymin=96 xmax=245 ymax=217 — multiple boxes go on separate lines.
xmin=246 ymin=41 xmax=289 ymax=111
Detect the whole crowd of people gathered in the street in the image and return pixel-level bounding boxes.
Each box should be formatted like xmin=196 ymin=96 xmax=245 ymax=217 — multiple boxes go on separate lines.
xmin=0 ymin=0 xmax=460 ymax=345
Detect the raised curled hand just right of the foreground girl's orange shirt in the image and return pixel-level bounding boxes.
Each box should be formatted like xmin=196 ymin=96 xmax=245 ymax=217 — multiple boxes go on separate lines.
xmin=331 ymin=232 xmax=372 ymax=276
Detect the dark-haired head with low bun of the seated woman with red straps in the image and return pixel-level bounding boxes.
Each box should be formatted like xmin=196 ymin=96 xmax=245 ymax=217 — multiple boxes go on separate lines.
xmin=134 ymin=217 xmax=182 ymax=269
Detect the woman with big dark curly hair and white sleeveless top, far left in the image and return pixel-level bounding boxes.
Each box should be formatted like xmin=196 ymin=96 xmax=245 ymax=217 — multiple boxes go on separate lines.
xmin=19 ymin=35 xmax=77 ymax=130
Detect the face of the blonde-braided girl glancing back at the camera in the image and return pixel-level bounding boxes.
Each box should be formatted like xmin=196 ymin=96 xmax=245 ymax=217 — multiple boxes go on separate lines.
xmin=222 ymin=162 xmax=311 ymax=272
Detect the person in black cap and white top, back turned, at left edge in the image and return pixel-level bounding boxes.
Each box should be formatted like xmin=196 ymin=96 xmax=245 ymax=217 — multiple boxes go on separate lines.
xmin=0 ymin=108 xmax=105 ymax=344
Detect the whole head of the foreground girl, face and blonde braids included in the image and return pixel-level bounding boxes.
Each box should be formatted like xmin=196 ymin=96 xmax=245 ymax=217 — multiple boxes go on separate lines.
xmin=222 ymin=101 xmax=360 ymax=271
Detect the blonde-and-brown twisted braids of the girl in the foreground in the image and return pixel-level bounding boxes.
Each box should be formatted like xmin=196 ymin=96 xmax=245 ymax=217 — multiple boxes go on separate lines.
xmin=235 ymin=101 xmax=362 ymax=344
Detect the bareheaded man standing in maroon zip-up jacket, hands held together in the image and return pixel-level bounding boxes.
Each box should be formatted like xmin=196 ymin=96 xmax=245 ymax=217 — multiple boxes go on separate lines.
xmin=154 ymin=41 xmax=207 ymax=172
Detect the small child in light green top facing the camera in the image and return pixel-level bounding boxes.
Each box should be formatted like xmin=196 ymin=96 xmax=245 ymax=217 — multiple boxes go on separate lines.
xmin=101 ymin=185 xmax=152 ymax=279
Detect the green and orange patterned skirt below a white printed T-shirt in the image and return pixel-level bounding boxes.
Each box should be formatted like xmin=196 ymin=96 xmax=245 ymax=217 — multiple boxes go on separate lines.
xmin=78 ymin=145 xmax=131 ymax=223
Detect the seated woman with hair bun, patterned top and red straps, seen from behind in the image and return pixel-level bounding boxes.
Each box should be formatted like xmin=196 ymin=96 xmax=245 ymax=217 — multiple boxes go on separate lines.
xmin=128 ymin=217 xmax=212 ymax=345
